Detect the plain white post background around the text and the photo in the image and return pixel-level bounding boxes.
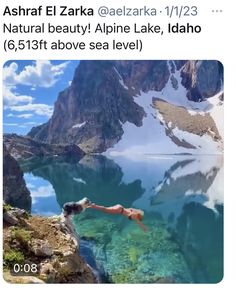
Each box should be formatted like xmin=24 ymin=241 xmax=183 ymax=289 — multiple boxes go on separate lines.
xmin=0 ymin=0 xmax=236 ymax=289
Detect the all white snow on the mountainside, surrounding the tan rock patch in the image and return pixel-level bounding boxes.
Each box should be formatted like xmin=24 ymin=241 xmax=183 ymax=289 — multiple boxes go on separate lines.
xmin=105 ymin=63 xmax=223 ymax=156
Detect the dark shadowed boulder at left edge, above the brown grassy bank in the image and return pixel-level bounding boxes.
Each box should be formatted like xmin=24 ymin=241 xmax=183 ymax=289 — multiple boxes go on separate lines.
xmin=3 ymin=145 xmax=31 ymax=211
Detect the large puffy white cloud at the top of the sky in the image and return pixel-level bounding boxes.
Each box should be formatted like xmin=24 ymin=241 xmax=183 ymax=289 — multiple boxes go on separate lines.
xmin=3 ymin=60 xmax=69 ymax=89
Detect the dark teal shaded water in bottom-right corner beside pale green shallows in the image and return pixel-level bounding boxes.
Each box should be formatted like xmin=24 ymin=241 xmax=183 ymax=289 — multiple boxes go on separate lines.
xmin=174 ymin=203 xmax=223 ymax=283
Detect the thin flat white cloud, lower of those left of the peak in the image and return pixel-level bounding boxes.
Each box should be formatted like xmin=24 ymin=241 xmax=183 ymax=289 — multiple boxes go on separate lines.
xmin=8 ymin=103 xmax=53 ymax=117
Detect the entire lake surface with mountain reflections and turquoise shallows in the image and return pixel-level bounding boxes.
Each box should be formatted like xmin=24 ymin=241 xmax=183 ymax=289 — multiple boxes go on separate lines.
xmin=21 ymin=156 xmax=223 ymax=283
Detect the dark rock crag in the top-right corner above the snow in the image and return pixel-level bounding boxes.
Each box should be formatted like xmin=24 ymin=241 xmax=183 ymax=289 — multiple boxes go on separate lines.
xmin=181 ymin=60 xmax=223 ymax=101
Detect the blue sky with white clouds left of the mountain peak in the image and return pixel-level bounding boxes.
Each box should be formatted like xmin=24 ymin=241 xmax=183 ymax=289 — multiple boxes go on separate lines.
xmin=3 ymin=60 xmax=79 ymax=135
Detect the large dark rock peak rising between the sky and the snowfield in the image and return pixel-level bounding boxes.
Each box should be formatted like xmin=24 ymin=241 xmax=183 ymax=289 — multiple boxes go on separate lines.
xmin=29 ymin=61 xmax=144 ymax=152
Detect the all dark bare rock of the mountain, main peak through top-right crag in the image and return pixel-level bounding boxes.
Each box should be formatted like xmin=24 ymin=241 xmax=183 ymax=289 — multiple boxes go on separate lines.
xmin=28 ymin=60 xmax=223 ymax=153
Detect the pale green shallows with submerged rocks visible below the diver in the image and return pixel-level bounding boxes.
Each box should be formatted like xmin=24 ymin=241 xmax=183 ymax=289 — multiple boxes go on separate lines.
xmin=75 ymin=217 xmax=192 ymax=283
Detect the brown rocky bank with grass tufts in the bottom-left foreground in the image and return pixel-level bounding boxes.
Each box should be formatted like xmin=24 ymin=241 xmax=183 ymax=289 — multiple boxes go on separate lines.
xmin=3 ymin=204 xmax=98 ymax=283
